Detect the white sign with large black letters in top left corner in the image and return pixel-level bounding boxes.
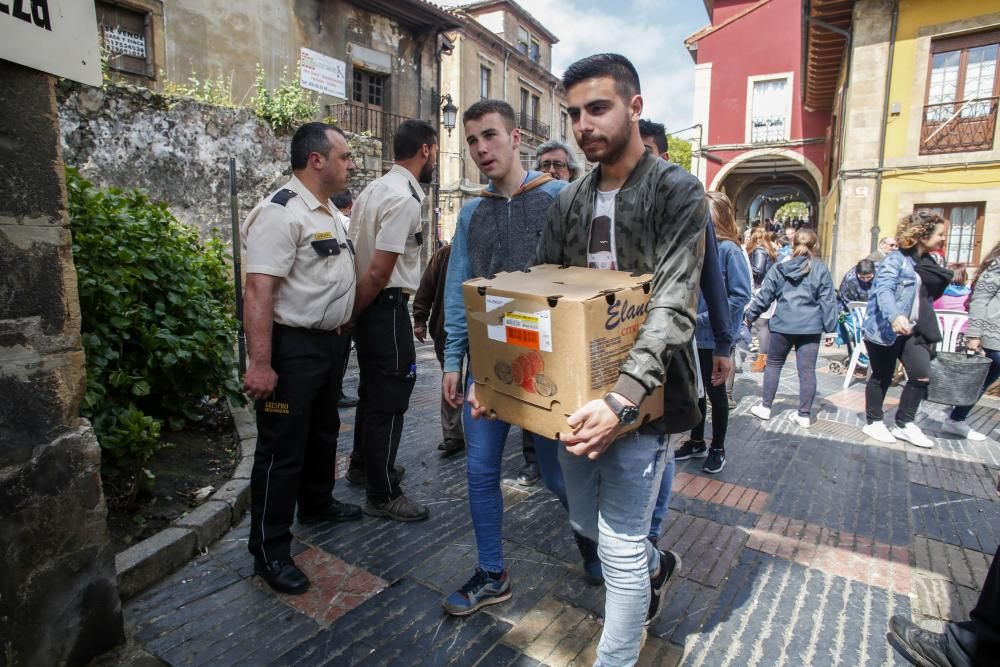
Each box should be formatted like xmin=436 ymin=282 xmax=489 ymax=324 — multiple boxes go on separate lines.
xmin=0 ymin=0 xmax=102 ymax=86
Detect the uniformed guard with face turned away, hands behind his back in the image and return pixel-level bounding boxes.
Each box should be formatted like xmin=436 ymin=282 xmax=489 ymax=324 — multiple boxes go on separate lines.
xmin=348 ymin=119 xmax=437 ymax=521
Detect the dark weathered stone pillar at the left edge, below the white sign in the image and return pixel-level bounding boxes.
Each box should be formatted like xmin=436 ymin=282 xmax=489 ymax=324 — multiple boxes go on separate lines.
xmin=0 ymin=61 xmax=123 ymax=666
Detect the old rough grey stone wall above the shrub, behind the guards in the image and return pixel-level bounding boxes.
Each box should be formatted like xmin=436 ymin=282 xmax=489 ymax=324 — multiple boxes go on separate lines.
xmin=58 ymin=81 xmax=382 ymax=240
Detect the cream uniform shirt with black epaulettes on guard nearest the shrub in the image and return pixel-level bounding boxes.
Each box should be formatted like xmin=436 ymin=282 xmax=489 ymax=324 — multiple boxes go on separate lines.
xmin=240 ymin=176 xmax=356 ymax=331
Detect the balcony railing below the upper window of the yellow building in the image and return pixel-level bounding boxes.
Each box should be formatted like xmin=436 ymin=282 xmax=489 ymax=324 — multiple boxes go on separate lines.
xmin=920 ymin=97 xmax=1000 ymax=155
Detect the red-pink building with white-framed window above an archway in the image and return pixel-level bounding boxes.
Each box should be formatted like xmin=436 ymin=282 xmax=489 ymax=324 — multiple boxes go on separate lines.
xmin=685 ymin=0 xmax=830 ymax=228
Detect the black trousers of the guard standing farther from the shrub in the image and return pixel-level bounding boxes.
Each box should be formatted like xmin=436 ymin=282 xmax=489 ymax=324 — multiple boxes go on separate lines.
xmin=352 ymin=287 xmax=417 ymax=503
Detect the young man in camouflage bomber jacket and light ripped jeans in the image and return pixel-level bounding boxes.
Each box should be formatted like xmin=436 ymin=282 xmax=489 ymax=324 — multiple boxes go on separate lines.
xmin=536 ymin=54 xmax=709 ymax=665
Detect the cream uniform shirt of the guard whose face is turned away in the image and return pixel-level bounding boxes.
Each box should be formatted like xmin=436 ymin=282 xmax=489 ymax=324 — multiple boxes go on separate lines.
xmin=350 ymin=164 xmax=424 ymax=294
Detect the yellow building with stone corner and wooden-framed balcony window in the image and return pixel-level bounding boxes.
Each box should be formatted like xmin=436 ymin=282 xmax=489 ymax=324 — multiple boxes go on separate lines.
xmin=803 ymin=0 xmax=1000 ymax=275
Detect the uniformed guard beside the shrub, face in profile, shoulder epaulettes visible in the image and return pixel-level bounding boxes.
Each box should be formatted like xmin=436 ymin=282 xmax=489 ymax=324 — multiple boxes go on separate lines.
xmin=240 ymin=123 xmax=361 ymax=594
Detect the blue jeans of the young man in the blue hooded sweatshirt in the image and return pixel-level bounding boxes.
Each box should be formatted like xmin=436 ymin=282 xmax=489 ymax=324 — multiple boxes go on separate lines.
xmin=462 ymin=375 xmax=568 ymax=572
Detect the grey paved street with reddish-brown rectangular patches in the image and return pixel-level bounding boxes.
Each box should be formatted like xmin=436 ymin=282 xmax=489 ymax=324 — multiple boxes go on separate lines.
xmin=125 ymin=345 xmax=1000 ymax=666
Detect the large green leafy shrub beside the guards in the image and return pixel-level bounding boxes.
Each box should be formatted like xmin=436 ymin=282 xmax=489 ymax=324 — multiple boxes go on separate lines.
xmin=66 ymin=169 xmax=239 ymax=495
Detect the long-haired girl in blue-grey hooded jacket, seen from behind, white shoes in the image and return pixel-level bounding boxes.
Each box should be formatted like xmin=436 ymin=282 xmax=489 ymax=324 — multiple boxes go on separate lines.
xmin=747 ymin=229 xmax=838 ymax=428
